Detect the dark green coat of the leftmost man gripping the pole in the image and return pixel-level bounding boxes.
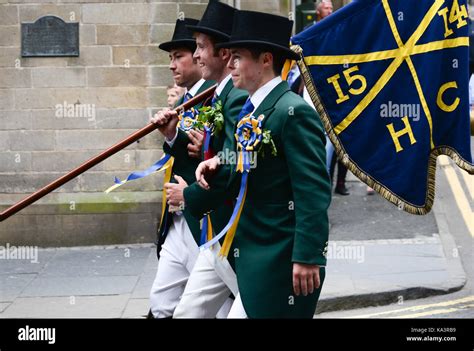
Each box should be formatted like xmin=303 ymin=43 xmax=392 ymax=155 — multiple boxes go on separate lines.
xmin=158 ymin=81 xmax=215 ymax=253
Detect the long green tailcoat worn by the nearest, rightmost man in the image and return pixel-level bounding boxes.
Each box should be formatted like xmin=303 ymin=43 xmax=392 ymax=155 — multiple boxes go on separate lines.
xmin=185 ymin=82 xmax=331 ymax=318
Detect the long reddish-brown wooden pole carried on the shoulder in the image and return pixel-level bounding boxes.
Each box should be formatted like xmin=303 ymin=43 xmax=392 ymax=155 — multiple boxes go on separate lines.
xmin=0 ymin=85 xmax=216 ymax=222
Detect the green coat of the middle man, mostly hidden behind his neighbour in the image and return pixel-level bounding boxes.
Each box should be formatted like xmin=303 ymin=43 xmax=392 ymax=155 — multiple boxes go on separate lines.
xmin=184 ymin=80 xmax=248 ymax=266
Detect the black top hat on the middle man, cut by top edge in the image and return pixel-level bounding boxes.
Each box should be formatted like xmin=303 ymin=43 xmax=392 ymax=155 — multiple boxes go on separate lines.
xmin=187 ymin=0 xmax=237 ymax=41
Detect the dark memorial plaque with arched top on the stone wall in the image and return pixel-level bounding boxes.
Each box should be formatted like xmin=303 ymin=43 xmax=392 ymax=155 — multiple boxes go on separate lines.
xmin=21 ymin=16 xmax=79 ymax=57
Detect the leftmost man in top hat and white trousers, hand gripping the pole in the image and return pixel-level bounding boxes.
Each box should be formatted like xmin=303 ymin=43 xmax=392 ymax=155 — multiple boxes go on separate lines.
xmin=149 ymin=19 xmax=218 ymax=318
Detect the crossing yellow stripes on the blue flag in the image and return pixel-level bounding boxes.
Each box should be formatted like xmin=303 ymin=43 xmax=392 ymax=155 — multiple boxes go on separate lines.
xmin=304 ymin=0 xmax=469 ymax=149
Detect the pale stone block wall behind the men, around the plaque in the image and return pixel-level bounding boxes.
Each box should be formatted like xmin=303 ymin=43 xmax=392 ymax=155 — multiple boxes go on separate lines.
xmin=0 ymin=0 xmax=207 ymax=246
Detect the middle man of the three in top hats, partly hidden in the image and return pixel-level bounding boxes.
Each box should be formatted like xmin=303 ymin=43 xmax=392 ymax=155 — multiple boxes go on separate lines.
xmin=163 ymin=0 xmax=248 ymax=318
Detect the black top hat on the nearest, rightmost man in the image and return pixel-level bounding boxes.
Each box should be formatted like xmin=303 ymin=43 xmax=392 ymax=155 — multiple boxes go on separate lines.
xmin=216 ymin=11 xmax=300 ymax=60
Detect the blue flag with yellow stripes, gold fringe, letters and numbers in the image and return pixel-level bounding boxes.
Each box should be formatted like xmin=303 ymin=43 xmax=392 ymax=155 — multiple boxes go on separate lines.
xmin=292 ymin=0 xmax=474 ymax=214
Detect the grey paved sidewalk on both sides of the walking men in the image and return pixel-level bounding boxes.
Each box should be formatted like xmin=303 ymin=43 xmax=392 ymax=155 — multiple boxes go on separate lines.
xmin=0 ymin=166 xmax=466 ymax=318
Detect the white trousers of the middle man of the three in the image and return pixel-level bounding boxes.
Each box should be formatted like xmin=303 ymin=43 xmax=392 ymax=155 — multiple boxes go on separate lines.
xmin=173 ymin=243 xmax=238 ymax=318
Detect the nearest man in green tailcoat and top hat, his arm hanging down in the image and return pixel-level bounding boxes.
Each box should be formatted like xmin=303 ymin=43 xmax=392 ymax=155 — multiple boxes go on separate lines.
xmin=189 ymin=11 xmax=331 ymax=318
